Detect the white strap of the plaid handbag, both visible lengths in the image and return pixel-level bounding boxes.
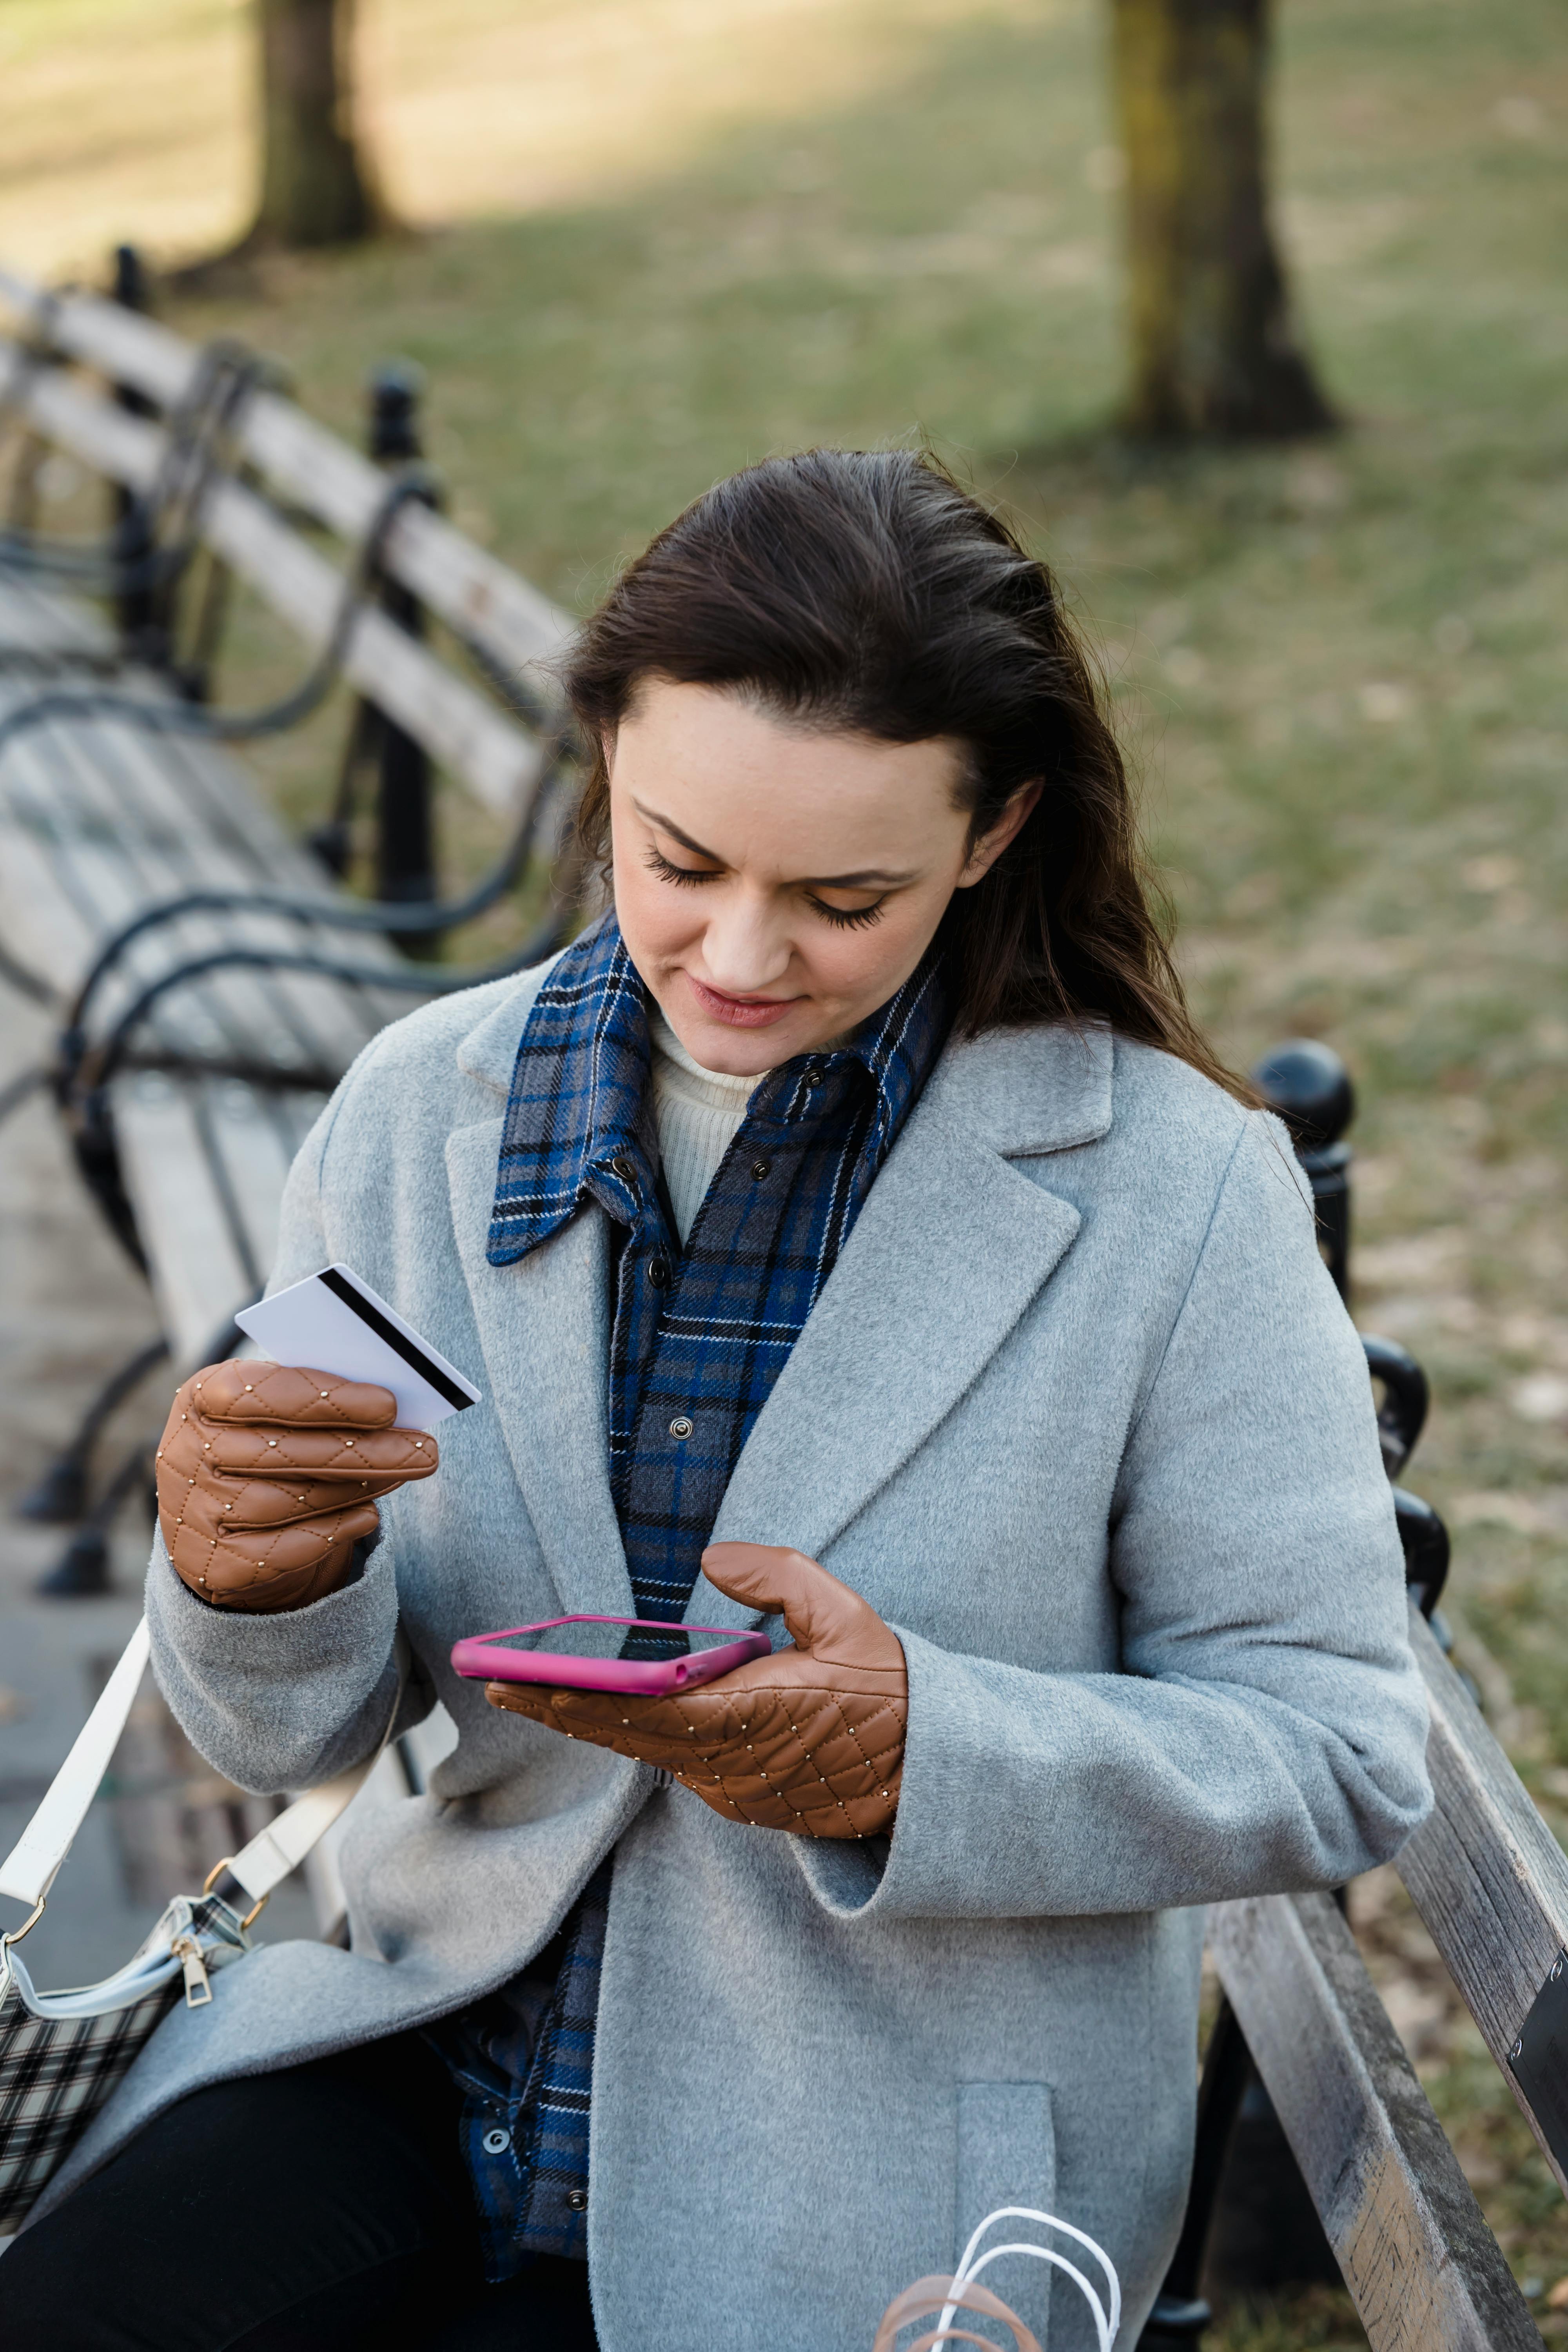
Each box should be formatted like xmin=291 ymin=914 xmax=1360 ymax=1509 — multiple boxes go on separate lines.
xmin=0 ymin=1618 xmax=409 ymax=1943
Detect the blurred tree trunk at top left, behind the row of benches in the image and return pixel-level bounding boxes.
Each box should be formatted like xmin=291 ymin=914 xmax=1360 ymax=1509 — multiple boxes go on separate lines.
xmin=256 ymin=0 xmax=381 ymax=247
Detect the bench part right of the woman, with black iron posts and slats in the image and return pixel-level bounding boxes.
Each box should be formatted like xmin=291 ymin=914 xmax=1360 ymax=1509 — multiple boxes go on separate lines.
xmin=1143 ymin=1047 xmax=1568 ymax=2352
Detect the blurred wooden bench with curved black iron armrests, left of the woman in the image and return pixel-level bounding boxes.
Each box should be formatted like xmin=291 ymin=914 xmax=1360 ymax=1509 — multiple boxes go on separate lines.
xmin=0 ymin=254 xmax=571 ymax=1926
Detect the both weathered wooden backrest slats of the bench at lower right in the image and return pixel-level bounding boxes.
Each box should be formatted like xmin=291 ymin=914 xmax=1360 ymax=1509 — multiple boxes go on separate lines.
xmin=1210 ymin=1609 xmax=1568 ymax=2352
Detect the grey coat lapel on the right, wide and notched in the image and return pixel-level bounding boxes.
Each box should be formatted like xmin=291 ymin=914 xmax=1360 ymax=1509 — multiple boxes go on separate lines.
xmin=686 ymin=1030 xmax=1112 ymax=1625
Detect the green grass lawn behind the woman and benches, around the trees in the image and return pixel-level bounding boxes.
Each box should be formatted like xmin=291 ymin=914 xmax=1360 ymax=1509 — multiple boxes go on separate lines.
xmin=0 ymin=0 xmax=1568 ymax=2352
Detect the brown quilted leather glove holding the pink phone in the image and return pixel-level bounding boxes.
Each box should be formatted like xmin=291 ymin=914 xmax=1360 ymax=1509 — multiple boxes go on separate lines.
xmin=484 ymin=1543 xmax=910 ymax=1837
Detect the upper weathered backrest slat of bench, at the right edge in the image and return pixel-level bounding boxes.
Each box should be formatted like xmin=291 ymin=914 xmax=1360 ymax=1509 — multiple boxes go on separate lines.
xmin=1394 ymin=1611 xmax=1568 ymax=2192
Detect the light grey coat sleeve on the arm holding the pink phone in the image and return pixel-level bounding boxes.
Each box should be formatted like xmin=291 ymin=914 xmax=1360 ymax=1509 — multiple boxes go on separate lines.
xmin=795 ymin=1115 xmax=1432 ymax=1917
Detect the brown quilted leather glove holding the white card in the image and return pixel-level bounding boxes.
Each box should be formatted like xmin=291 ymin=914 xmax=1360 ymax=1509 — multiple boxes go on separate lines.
xmin=158 ymin=1364 xmax=439 ymax=1611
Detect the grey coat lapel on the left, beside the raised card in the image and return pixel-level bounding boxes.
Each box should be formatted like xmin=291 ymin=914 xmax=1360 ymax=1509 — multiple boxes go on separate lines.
xmin=446 ymin=1117 xmax=632 ymax=1616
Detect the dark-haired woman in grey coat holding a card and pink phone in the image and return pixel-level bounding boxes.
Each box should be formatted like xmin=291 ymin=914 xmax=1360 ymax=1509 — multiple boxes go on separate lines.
xmin=0 ymin=452 xmax=1427 ymax=2352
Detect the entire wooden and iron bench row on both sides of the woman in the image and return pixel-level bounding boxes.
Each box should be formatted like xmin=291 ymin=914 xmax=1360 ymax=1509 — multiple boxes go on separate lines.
xmin=0 ymin=258 xmax=1568 ymax=2352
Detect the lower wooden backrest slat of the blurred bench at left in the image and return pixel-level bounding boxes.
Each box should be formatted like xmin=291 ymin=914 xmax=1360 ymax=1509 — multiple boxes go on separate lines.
xmin=0 ymin=341 xmax=545 ymax=821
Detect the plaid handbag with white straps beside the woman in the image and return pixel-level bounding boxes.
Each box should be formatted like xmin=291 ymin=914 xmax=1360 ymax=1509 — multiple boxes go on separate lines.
xmin=0 ymin=1618 xmax=407 ymax=2234
